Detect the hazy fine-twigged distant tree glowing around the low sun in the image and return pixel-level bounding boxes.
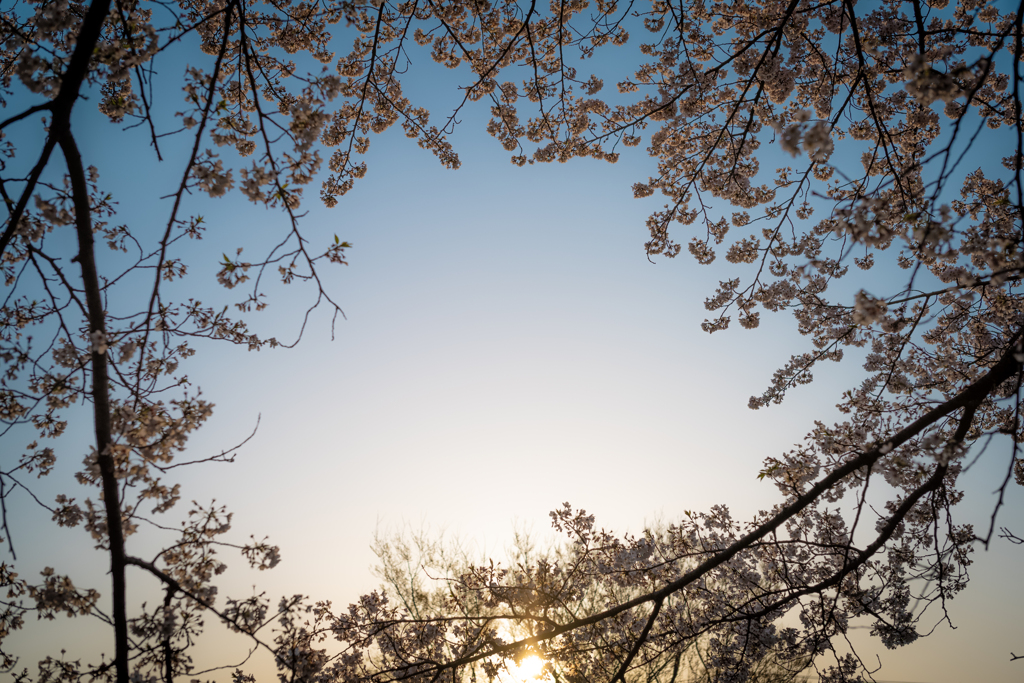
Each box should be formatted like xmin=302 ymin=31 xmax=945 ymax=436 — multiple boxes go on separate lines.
xmin=374 ymin=525 xmax=810 ymax=683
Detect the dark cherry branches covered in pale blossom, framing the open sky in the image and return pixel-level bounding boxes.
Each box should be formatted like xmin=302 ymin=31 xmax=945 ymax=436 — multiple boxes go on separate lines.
xmin=0 ymin=0 xmax=1024 ymax=683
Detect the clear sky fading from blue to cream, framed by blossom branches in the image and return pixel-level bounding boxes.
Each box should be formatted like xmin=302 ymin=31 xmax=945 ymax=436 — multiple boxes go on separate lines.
xmin=2 ymin=10 xmax=1024 ymax=683
